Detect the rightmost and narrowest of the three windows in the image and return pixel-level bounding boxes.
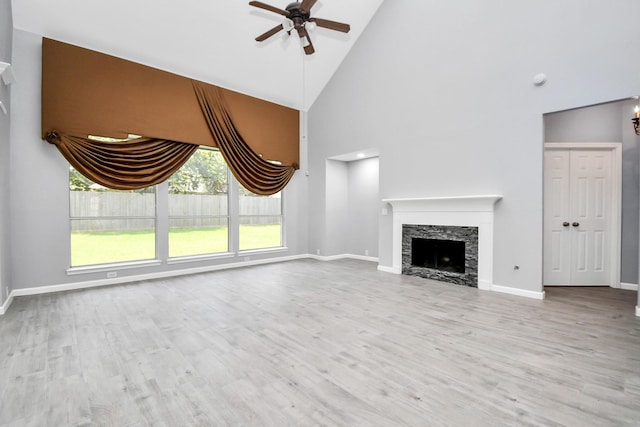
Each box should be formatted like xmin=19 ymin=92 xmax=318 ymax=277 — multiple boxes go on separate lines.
xmin=238 ymin=184 xmax=282 ymax=251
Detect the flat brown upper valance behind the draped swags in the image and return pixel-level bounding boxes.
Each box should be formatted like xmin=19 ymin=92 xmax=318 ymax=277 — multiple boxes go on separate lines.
xmin=42 ymin=38 xmax=299 ymax=165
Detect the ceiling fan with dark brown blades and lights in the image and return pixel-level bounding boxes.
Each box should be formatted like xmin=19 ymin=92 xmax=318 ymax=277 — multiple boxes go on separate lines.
xmin=249 ymin=0 xmax=351 ymax=55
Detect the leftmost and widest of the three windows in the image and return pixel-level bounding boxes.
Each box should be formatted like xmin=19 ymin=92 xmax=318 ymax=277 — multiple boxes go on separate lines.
xmin=69 ymin=167 xmax=156 ymax=267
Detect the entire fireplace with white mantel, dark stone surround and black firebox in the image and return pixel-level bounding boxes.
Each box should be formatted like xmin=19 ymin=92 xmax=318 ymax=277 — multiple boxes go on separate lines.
xmin=381 ymin=195 xmax=502 ymax=290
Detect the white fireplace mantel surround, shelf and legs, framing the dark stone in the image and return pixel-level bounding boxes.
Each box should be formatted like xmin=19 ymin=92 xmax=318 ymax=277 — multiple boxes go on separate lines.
xmin=382 ymin=194 xmax=502 ymax=290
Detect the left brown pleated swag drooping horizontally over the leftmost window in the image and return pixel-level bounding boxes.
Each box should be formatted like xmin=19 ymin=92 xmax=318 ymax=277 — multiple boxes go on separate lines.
xmin=46 ymin=131 xmax=198 ymax=190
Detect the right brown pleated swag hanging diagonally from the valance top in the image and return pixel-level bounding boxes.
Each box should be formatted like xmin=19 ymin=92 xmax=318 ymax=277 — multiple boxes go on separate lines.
xmin=193 ymin=80 xmax=298 ymax=196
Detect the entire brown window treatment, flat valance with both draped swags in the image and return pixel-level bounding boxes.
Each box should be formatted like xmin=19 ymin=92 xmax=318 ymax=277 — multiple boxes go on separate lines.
xmin=41 ymin=38 xmax=299 ymax=195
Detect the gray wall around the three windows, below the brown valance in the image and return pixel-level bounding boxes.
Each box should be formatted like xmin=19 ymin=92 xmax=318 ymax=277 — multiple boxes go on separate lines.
xmin=8 ymin=30 xmax=309 ymax=290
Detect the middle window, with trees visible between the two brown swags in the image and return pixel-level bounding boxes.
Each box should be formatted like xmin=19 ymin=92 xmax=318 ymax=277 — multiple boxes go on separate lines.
xmin=169 ymin=148 xmax=229 ymax=257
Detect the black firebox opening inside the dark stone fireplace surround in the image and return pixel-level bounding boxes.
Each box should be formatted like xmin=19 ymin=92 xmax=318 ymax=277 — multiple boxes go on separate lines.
xmin=411 ymin=237 xmax=465 ymax=274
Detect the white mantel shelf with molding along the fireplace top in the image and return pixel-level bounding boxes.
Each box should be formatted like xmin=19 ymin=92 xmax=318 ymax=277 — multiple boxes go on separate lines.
xmin=382 ymin=194 xmax=502 ymax=212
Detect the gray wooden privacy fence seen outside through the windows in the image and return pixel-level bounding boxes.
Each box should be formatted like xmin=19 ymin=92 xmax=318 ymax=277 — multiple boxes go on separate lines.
xmin=70 ymin=191 xmax=281 ymax=232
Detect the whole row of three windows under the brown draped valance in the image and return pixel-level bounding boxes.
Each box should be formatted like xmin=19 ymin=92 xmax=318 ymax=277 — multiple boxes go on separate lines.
xmin=69 ymin=148 xmax=283 ymax=267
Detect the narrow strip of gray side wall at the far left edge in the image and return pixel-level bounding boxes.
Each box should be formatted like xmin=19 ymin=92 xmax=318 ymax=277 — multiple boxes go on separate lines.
xmin=0 ymin=0 xmax=13 ymax=306
